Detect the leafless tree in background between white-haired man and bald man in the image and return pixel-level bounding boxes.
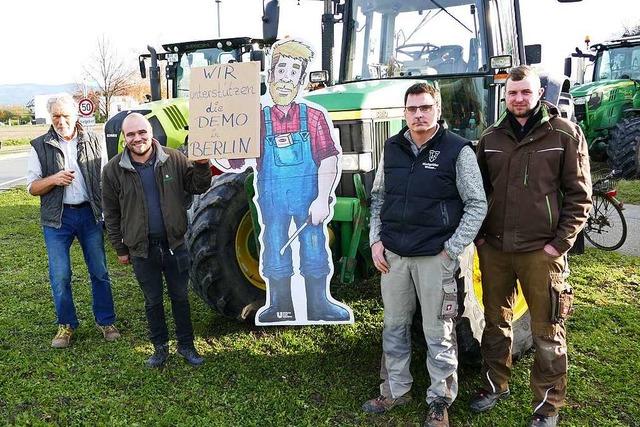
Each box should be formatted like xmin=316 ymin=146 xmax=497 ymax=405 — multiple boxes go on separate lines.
xmin=84 ymin=34 xmax=135 ymax=119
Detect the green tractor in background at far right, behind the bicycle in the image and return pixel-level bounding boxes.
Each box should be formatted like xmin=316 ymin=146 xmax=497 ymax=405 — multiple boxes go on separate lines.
xmin=565 ymin=35 xmax=640 ymax=178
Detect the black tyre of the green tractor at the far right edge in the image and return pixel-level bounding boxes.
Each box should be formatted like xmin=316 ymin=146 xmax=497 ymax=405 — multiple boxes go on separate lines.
xmin=607 ymin=117 xmax=640 ymax=179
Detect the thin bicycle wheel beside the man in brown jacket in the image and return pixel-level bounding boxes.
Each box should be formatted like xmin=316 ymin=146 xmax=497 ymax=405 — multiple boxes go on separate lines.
xmin=584 ymin=194 xmax=627 ymax=251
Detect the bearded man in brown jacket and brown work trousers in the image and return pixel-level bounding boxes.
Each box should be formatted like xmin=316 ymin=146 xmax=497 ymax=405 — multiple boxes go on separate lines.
xmin=471 ymin=66 xmax=591 ymax=427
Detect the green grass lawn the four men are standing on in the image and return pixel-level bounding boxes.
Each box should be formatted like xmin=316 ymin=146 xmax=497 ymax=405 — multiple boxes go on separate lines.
xmin=0 ymin=188 xmax=640 ymax=427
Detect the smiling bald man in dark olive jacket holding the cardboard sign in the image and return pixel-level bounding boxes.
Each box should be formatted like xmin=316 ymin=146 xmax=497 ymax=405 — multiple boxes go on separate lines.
xmin=102 ymin=113 xmax=211 ymax=368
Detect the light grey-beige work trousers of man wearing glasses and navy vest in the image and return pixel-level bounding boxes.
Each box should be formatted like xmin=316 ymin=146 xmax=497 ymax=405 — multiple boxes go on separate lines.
xmin=380 ymin=250 xmax=458 ymax=405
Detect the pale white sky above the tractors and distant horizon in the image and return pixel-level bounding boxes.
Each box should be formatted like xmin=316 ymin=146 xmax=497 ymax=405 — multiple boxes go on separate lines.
xmin=0 ymin=0 xmax=640 ymax=85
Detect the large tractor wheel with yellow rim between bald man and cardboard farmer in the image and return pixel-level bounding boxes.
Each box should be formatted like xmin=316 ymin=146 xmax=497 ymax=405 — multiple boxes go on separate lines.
xmin=187 ymin=172 xmax=265 ymax=321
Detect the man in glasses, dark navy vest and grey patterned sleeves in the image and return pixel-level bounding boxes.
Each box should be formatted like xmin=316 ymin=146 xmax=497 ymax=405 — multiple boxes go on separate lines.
xmin=362 ymin=83 xmax=487 ymax=427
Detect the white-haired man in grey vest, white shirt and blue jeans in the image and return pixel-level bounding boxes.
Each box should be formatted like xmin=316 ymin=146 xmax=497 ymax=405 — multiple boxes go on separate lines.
xmin=27 ymin=94 xmax=120 ymax=348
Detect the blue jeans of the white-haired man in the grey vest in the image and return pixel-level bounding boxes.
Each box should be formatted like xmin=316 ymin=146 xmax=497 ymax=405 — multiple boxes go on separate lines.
xmin=43 ymin=205 xmax=116 ymax=329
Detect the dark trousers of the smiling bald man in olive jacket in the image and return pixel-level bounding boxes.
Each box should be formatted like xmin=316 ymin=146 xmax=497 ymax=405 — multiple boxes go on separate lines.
xmin=131 ymin=241 xmax=193 ymax=348
